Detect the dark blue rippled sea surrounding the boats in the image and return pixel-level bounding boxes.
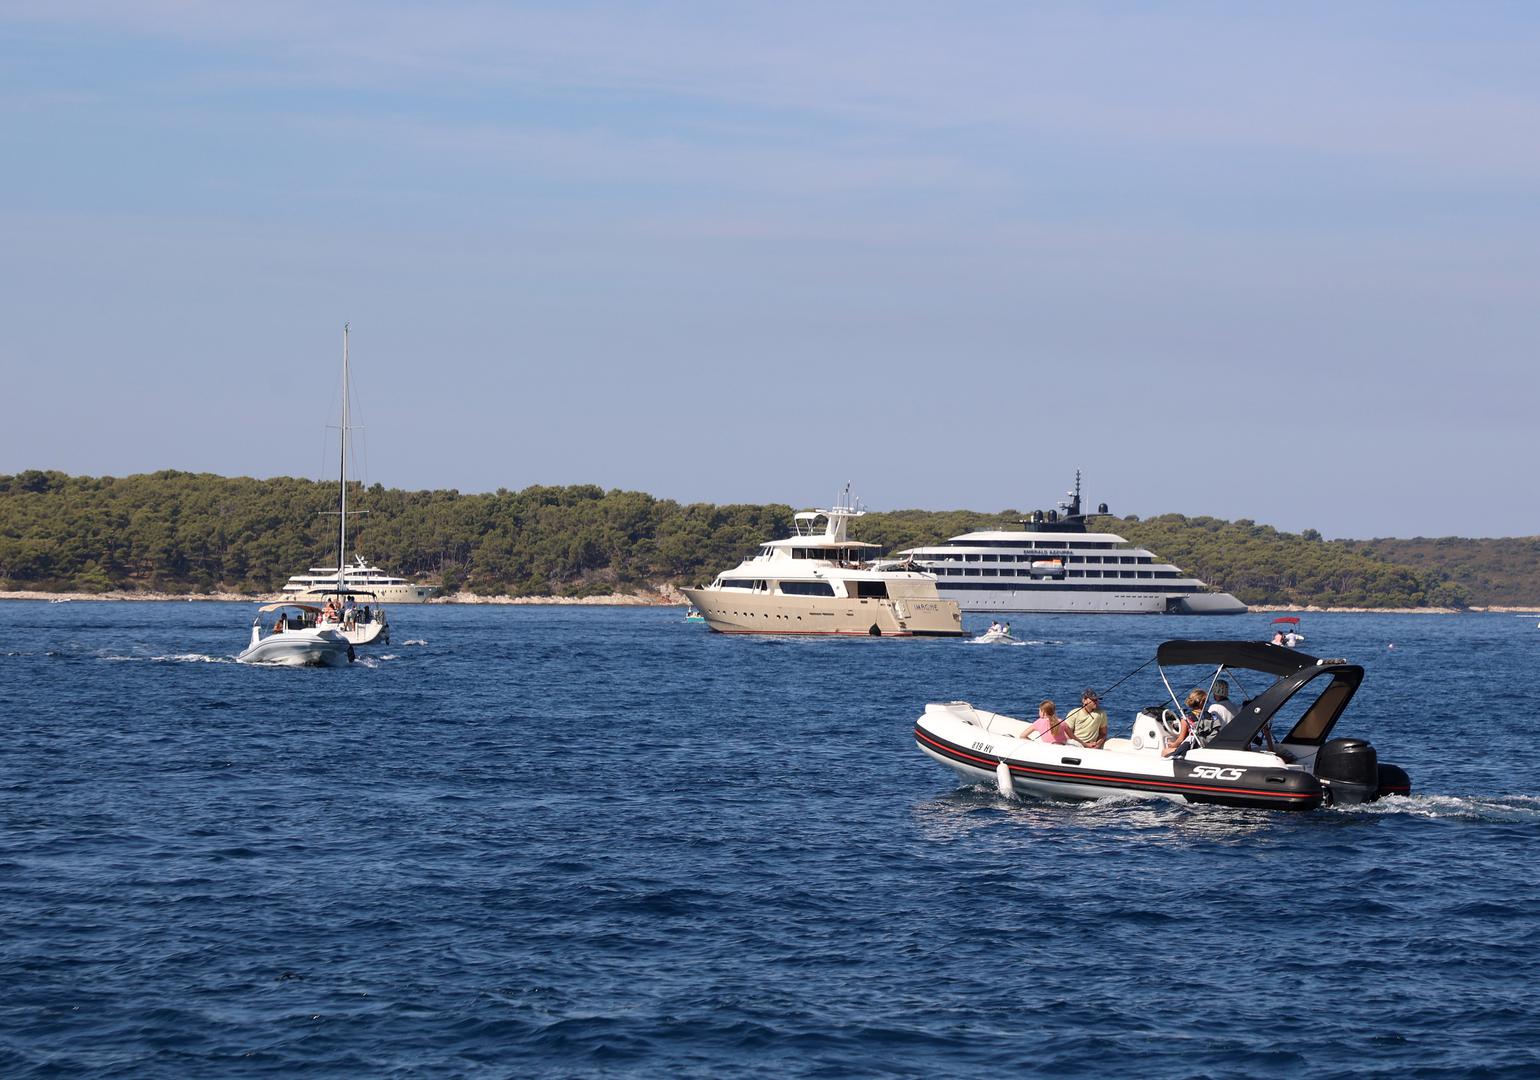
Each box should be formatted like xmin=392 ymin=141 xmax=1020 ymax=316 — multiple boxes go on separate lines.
xmin=0 ymin=601 xmax=1540 ymax=1078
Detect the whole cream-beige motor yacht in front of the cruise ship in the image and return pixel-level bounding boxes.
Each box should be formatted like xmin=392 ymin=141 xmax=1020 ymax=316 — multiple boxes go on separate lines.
xmin=682 ymin=487 xmax=966 ymax=638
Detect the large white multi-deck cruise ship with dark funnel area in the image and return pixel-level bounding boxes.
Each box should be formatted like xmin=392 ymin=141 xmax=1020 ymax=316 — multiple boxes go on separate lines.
xmin=898 ymin=473 xmax=1246 ymax=615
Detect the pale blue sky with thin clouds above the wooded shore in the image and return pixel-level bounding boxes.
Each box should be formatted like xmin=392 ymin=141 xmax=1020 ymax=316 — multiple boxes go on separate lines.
xmin=0 ymin=0 xmax=1540 ymax=536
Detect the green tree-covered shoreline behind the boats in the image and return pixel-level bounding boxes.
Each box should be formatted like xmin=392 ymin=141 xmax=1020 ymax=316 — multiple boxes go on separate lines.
xmin=0 ymin=471 xmax=1540 ymax=607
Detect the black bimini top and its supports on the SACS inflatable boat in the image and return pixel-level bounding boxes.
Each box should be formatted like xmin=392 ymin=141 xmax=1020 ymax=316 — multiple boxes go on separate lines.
xmin=1155 ymin=641 xmax=1363 ymax=750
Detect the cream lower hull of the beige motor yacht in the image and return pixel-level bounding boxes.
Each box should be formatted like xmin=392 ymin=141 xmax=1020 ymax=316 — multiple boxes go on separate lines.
xmin=681 ymin=589 xmax=967 ymax=638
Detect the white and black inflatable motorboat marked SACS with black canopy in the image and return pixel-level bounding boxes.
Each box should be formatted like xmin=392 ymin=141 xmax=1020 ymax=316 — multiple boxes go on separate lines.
xmin=915 ymin=641 xmax=1411 ymax=810
